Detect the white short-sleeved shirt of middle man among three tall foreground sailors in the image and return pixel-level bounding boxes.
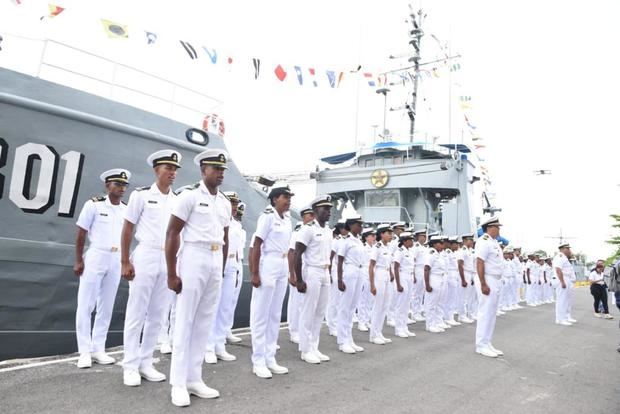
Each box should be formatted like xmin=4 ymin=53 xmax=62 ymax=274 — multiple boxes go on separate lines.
xmin=125 ymin=183 xmax=176 ymax=247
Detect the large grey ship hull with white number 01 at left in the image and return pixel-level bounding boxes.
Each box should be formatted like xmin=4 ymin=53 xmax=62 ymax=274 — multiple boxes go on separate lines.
xmin=0 ymin=69 xmax=266 ymax=360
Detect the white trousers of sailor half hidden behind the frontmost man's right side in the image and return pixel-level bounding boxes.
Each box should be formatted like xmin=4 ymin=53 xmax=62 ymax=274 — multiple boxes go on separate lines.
xmin=207 ymin=257 xmax=241 ymax=352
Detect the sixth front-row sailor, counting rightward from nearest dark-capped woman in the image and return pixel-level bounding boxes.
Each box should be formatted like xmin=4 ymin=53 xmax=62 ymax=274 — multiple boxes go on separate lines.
xmin=424 ymin=233 xmax=448 ymax=333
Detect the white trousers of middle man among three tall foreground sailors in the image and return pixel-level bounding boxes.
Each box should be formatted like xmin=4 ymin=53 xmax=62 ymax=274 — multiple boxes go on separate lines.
xmin=123 ymin=243 xmax=172 ymax=370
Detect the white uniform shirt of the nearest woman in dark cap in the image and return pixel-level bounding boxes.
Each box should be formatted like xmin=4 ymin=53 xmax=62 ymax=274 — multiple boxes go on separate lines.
xmin=256 ymin=210 xmax=293 ymax=256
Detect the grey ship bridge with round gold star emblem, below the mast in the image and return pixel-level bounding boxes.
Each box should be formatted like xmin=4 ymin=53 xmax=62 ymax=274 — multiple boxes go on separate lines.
xmin=316 ymin=142 xmax=482 ymax=234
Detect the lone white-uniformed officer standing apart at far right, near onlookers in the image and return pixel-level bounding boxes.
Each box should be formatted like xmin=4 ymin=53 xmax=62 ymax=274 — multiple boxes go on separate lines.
xmin=553 ymin=243 xmax=577 ymax=326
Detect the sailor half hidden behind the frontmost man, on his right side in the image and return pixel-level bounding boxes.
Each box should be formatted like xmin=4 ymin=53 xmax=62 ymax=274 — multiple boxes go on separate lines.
xmin=205 ymin=191 xmax=244 ymax=364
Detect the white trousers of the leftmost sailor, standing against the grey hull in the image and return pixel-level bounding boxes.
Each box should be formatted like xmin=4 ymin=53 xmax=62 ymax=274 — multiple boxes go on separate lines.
xmin=75 ymin=247 xmax=121 ymax=354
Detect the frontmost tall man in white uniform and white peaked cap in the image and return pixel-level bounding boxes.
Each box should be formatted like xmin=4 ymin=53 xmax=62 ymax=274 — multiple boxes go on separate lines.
xmin=165 ymin=149 xmax=231 ymax=407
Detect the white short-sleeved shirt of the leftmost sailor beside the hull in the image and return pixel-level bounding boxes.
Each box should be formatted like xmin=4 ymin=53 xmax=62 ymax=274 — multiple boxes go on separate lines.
xmin=76 ymin=197 xmax=127 ymax=250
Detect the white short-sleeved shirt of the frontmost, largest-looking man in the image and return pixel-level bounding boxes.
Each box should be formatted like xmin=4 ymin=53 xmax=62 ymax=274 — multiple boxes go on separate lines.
xmin=172 ymin=181 xmax=232 ymax=246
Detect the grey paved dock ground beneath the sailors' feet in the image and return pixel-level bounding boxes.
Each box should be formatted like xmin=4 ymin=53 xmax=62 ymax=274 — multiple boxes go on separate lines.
xmin=0 ymin=288 xmax=620 ymax=414
